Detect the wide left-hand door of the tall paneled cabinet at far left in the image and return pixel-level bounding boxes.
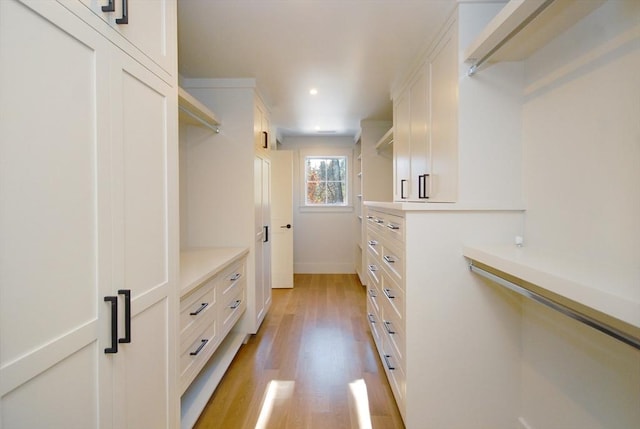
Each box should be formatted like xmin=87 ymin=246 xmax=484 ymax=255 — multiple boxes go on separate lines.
xmin=0 ymin=0 xmax=111 ymax=429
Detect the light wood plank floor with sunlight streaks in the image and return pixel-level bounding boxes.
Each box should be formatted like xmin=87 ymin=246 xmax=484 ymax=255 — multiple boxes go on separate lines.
xmin=195 ymin=274 xmax=404 ymax=429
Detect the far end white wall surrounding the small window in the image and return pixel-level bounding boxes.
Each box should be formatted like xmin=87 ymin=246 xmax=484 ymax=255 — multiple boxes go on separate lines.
xmin=280 ymin=137 xmax=356 ymax=273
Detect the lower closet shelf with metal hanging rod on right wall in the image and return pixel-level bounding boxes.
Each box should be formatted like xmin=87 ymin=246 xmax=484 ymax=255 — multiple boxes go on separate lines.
xmin=463 ymin=245 xmax=640 ymax=349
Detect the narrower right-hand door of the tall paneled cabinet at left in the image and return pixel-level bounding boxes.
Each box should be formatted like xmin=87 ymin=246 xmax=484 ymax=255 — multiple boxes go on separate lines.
xmin=106 ymin=46 xmax=178 ymax=429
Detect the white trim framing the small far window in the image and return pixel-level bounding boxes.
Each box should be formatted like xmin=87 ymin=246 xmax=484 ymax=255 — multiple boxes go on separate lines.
xmin=298 ymin=147 xmax=354 ymax=213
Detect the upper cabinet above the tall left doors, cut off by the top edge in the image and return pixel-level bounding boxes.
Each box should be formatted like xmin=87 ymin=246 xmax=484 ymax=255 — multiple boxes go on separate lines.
xmin=65 ymin=0 xmax=178 ymax=78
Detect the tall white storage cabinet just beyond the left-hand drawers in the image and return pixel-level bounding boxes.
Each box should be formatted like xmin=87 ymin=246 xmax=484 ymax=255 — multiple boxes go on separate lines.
xmin=183 ymin=79 xmax=272 ymax=333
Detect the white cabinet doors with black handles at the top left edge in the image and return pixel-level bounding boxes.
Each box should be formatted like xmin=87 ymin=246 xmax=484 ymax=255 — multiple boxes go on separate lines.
xmin=74 ymin=0 xmax=177 ymax=76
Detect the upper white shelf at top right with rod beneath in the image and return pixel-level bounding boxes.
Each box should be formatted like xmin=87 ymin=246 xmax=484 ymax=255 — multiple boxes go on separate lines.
xmin=464 ymin=0 xmax=604 ymax=73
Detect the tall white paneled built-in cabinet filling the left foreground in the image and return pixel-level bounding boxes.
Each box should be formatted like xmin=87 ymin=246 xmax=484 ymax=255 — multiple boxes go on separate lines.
xmin=0 ymin=0 xmax=178 ymax=429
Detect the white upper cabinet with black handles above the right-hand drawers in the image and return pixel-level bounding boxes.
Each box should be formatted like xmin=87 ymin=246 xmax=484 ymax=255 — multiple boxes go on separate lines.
xmin=393 ymin=18 xmax=458 ymax=202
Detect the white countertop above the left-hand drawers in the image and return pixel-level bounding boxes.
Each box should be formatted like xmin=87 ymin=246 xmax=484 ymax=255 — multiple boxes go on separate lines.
xmin=180 ymin=247 xmax=249 ymax=296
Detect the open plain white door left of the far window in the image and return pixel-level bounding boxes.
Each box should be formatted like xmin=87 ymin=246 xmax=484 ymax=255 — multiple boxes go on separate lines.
xmin=271 ymin=150 xmax=293 ymax=288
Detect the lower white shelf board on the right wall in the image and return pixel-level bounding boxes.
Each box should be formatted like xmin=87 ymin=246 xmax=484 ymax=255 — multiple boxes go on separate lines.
xmin=463 ymin=245 xmax=640 ymax=339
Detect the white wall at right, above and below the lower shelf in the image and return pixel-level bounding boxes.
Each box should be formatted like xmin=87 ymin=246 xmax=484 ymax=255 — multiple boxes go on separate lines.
xmin=522 ymin=0 xmax=640 ymax=429
